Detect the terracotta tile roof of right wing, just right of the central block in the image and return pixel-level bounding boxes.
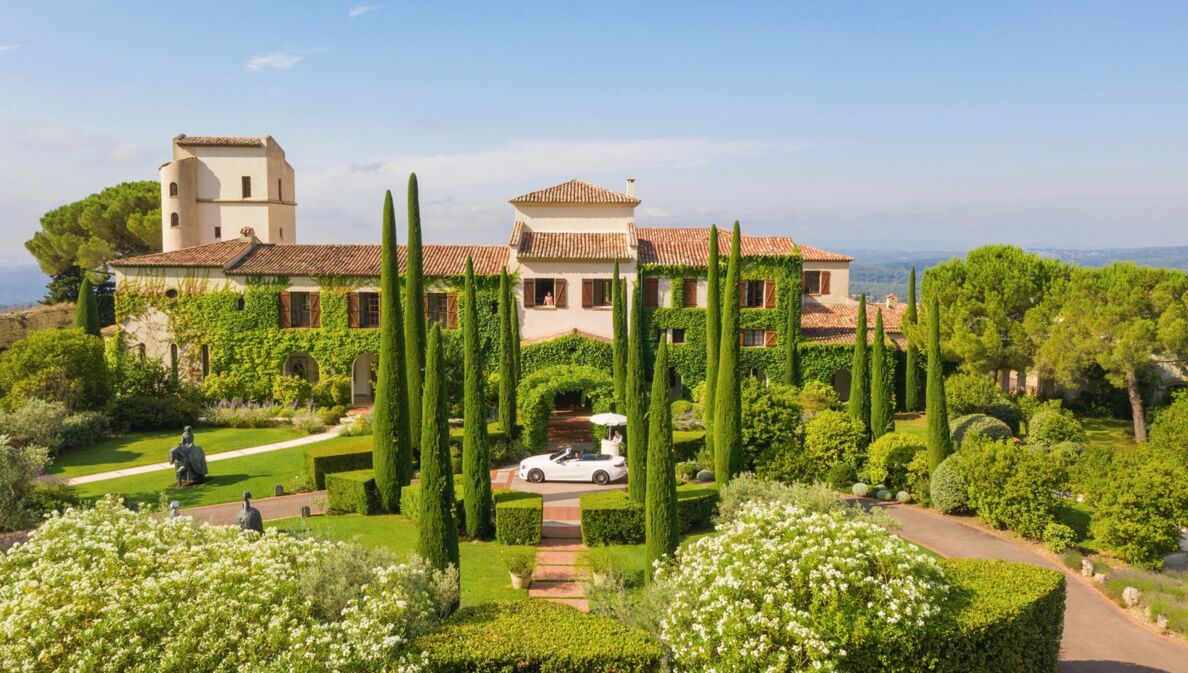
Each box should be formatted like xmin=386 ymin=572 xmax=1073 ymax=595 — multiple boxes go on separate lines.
xmin=637 ymin=227 xmax=794 ymax=266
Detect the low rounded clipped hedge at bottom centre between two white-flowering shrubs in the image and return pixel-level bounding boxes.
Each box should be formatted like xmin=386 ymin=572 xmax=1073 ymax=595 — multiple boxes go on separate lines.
xmin=415 ymin=600 xmax=663 ymax=673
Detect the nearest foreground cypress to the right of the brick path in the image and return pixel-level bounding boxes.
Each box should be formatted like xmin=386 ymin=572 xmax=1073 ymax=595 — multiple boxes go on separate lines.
xmin=644 ymin=339 xmax=681 ymax=581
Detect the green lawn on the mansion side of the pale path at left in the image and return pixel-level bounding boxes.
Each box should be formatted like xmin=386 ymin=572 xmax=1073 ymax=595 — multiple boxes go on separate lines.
xmin=49 ymin=426 xmax=304 ymax=478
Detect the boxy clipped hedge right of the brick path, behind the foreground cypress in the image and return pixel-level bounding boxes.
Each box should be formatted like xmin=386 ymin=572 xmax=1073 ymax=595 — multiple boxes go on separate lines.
xmin=581 ymin=484 xmax=718 ymax=545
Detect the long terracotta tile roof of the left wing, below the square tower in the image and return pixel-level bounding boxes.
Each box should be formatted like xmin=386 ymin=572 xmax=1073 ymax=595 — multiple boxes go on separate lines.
xmin=112 ymin=240 xmax=507 ymax=277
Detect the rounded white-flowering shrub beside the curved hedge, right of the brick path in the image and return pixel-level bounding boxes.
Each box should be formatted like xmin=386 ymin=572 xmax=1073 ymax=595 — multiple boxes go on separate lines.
xmin=657 ymin=503 xmax=947 ymax=673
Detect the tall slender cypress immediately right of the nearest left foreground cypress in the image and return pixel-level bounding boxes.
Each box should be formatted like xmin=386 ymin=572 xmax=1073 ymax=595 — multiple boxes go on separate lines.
xmin=462 ymin=257 xmax=492 ymax=537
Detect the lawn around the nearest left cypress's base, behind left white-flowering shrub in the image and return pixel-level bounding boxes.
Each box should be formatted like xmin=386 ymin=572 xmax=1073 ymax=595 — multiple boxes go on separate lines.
xmin=267 ymin=514 xmax=532 ymax=604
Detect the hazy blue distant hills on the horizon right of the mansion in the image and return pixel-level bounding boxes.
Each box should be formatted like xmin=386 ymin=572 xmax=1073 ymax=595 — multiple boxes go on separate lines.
xmin=846 ymin=246 xmax=1188 ymax=300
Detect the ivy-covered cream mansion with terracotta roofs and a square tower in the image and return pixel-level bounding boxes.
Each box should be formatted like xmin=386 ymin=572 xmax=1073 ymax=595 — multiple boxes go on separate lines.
xmin=110 ymin=136 xmax=903 ymax=403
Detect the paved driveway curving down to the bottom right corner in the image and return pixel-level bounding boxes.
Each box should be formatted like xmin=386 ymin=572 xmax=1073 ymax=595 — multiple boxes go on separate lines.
xmin=865 ymin=501 xmax=1188 ymax=673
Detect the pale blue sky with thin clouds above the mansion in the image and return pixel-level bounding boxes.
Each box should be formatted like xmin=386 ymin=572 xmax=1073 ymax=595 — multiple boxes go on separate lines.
xmin=0 ymin=0 xmax=1188 ymax=264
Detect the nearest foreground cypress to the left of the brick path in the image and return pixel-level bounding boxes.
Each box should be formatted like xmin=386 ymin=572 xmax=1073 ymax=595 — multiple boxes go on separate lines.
xmin=417 ymin=325 xmax=459 ymax=570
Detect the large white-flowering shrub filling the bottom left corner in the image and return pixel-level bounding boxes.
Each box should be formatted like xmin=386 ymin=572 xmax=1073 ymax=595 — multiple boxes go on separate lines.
xmin=0 ymin=496 xmax=457 ymax=673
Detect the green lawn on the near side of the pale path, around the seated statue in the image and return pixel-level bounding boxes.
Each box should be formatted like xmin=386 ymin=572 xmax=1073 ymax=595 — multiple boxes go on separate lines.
xmin=78 ymin=436 xmax=371 ymax=508
